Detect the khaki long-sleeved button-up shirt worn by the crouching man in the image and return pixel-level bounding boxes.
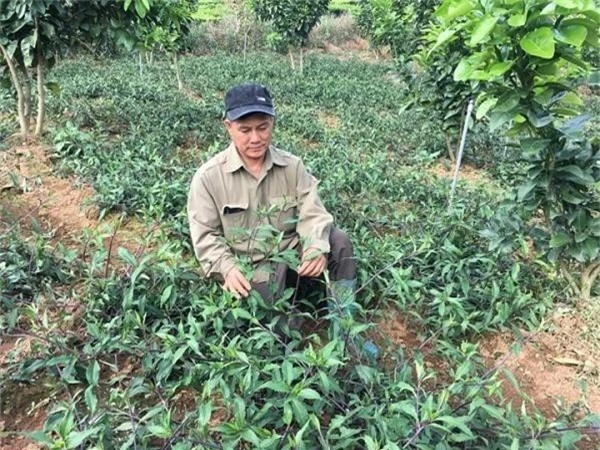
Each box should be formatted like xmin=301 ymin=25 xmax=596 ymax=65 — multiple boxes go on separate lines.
xmin=188 ymin=144 xmax=333 ymax=281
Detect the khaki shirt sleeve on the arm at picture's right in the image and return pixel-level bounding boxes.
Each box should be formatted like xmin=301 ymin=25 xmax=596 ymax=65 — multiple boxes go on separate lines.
xmin=296 ymin=161 xmax=333 ymax=253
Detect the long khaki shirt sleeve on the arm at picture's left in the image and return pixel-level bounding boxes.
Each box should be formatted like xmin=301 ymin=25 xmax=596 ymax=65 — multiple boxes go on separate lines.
xmin=187 ymin=170 xmax=235 ymax=278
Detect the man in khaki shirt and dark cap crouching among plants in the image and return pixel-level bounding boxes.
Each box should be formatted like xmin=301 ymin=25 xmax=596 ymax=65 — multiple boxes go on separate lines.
xmin=188 ymin=84 xmax=378 ymax=358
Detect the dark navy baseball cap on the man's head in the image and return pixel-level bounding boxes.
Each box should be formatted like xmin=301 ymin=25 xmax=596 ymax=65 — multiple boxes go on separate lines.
xmin=225 ymin=83 xmax=275 ymax=120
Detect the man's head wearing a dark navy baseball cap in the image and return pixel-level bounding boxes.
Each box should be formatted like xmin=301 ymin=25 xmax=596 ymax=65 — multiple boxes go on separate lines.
xmin=225 ymin=84 xmax=275 ymax=161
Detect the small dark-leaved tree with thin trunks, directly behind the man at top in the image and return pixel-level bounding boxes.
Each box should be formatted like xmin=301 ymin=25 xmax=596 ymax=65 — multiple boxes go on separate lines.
xmin=252 ymin=0 xmax=329 ymax=71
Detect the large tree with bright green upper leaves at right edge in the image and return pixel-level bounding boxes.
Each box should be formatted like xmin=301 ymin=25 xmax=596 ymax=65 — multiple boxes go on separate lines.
xmin=432 ymin=0 xmax=600 ymax=299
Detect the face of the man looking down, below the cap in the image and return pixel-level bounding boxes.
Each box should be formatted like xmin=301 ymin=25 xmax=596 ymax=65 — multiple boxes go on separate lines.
xmin=225 ymin=114 xmax=274 ymax=161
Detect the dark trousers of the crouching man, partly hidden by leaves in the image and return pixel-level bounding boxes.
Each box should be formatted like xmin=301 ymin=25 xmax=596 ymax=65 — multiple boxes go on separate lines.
xmin=251 ymin=228 xmax=356 ymax=301
